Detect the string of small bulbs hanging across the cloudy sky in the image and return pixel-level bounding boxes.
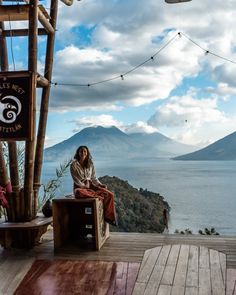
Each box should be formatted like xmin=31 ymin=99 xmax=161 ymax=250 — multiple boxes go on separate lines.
xmin=51 ymin=32 xmax=236 ymax=87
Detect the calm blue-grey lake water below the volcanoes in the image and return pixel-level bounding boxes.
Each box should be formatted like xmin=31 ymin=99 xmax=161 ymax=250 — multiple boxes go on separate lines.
xmin=42 ymin=159 xmax=236 ymax=235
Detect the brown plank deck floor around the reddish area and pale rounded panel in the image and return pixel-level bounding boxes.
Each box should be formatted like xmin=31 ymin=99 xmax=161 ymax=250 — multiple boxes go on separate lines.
xmin=0 ymin=231 xmax=236 ymax=295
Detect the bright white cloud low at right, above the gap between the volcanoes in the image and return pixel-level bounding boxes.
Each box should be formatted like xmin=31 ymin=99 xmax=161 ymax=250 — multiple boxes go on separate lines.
xmin=148 ymin=95 xmax=236 ymax=147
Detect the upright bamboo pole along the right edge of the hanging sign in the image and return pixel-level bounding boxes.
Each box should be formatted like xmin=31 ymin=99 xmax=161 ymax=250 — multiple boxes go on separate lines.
xmin=24 ymin=0 xmax=38 ymax=220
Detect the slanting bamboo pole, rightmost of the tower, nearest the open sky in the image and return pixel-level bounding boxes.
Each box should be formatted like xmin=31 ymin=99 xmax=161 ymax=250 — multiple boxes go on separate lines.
xmin=34 ymin=0 xmax=58 ymax=212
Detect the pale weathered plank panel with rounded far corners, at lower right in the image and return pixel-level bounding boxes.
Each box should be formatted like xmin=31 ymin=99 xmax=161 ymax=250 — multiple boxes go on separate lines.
xmin=132 ymin=245 xmax=226 ymax=295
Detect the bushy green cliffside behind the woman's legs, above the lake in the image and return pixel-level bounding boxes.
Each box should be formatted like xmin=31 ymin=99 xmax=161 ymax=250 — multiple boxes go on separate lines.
xmin=99 ymin=176 xmax=170 ymax=233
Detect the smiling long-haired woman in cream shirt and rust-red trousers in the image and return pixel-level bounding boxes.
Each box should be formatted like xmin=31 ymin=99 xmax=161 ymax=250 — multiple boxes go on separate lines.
xmin=70 ymin=146 xmax=117 ymax=225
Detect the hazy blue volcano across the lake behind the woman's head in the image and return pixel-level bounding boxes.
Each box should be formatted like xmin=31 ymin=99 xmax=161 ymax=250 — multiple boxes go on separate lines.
xmin=44 ymin=126 xmax=196 ymax=161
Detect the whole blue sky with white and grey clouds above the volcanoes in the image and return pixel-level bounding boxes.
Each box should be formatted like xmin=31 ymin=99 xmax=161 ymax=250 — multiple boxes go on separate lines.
xmin=10 ymin=0 xmax=236 ymax=147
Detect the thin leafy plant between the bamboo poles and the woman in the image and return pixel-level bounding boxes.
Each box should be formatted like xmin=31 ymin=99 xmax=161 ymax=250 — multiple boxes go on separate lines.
xmin=38 ymin=160 xmax=72 ymax=211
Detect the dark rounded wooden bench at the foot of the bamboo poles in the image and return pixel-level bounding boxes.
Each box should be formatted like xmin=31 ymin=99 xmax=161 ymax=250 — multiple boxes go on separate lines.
xmin=0 ymin=215 xmax=52 ymax=249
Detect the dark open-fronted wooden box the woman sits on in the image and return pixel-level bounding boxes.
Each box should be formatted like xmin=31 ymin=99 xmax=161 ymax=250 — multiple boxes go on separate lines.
xmin=53 ymin=196 xmax=109 ymax=251
